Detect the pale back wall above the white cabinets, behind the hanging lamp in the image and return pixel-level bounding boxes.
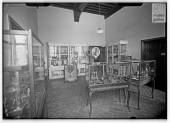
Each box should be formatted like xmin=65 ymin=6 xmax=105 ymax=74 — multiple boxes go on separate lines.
xmin=37 ymin=7 xmax=105 ymax=46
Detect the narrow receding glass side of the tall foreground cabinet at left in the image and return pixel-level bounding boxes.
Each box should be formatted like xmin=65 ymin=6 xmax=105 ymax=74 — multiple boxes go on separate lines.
xmin=32 ymin=35 xmax=47 ymax=118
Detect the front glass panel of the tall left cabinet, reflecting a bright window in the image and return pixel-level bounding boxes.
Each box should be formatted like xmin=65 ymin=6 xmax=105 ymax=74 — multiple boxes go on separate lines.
xmin=3 ymin=31 xmax=34 ymax=118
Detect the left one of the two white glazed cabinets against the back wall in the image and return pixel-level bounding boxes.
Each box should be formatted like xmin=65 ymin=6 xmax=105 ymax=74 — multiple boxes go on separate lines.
xmin=47 ymin=43 xmax=69 ymax=79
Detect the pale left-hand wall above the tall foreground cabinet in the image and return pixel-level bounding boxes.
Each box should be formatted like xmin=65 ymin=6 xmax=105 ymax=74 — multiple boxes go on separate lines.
xmin=3 ymin=4 xmax=38 ymax=35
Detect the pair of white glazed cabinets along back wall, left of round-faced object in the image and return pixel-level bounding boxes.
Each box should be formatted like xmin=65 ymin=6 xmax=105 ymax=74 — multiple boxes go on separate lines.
xmin=46 ymin=43 xmax=88 ymax=79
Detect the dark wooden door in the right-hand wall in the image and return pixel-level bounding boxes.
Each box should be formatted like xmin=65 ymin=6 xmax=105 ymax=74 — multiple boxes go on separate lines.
xmin=141 ymin=37 xmax=167 ymax=91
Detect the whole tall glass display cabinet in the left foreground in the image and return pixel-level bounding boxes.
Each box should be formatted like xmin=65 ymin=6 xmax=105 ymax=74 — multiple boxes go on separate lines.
xmin=3 ymin=30 xmax=46 ymax=118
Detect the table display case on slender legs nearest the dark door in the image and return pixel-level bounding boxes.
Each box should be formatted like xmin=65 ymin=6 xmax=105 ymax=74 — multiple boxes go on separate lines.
xmin=129 ymin=60 xmax=156 ymax=109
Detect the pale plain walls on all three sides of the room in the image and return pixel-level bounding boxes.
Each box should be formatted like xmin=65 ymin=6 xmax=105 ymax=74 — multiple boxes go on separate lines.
xmin=3 ymin=3 xmax=165 ymax=62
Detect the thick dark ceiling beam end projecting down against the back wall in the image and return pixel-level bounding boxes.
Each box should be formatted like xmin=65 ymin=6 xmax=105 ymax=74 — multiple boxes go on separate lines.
xmin=73 ymin=3 xmax=87 ymax=22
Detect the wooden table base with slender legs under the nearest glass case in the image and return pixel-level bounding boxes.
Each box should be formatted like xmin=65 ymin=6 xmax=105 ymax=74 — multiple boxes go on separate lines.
xmin=87 ymin=83 xmax=130 ymax=117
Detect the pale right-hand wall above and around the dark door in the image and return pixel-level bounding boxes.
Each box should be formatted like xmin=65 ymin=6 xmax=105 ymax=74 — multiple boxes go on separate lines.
xmin=105 ymin=3 xmax=165 ymax=59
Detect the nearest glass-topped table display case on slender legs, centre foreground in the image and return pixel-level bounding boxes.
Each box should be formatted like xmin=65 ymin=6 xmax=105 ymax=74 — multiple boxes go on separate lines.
xmin=86 ymin=62 xmax=131 ymax=117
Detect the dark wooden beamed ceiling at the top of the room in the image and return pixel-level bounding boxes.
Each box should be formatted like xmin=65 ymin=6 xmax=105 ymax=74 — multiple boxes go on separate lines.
xmin=26 ymin=2 xmax=142 ymax=22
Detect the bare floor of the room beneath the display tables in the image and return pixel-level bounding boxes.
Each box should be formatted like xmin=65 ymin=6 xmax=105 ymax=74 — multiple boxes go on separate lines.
xmin=47 ymin=77 xmax=166 ymax=118
